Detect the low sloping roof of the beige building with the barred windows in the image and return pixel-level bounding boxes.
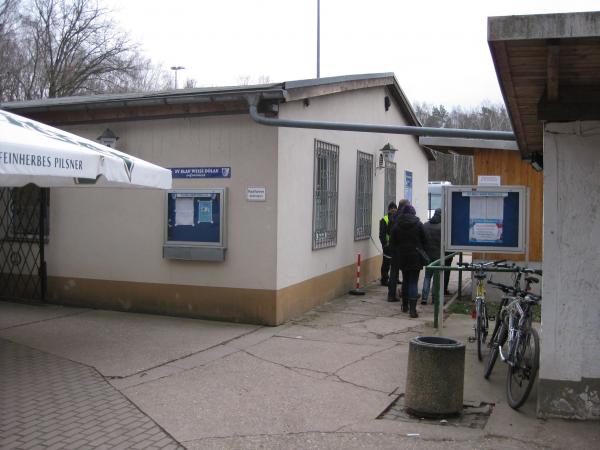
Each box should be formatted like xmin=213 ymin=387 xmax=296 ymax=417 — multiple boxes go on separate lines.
xmin=0 ymin=73 xmax=421 ymax=126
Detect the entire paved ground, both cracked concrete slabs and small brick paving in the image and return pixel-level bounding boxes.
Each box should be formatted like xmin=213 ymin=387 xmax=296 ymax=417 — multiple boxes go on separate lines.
xmin=0 ymin=278 xmax=600 ymax=449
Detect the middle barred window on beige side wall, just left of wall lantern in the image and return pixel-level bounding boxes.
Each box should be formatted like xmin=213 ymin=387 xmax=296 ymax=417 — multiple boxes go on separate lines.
xmin=354 ymin=151 xmax=373 ymax=241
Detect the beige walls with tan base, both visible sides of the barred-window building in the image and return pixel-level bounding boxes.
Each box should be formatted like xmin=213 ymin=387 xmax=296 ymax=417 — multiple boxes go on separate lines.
xmin=38 ymin=87 xmax=428 ymax=325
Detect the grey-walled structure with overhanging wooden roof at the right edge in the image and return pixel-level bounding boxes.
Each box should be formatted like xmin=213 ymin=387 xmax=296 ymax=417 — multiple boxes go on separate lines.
xmin=488 ymin=11 xmax=600 ymax=419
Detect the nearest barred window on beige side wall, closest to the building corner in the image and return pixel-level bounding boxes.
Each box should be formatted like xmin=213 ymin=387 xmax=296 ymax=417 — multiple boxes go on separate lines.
xmin=312 ymin=139 xmax=340 ymax=250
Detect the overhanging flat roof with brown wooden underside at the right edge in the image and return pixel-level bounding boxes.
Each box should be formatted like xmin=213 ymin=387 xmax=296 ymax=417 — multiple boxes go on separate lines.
xmin=488 ymin=11 xmax=600 ymax=158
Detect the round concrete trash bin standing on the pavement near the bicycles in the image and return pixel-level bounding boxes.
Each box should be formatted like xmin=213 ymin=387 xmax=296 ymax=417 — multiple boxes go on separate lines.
xmin=404 ymin=336 xmax=465 ymax=418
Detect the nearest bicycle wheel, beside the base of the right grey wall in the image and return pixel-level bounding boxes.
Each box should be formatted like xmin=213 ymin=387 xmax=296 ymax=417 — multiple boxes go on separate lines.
xmin=506 ymin=328 xmax=540 ymax=409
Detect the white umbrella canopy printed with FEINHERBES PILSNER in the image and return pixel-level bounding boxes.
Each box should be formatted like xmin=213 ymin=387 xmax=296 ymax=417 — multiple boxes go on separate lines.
xmin=0 ymin=110 xmax=171 ymax=189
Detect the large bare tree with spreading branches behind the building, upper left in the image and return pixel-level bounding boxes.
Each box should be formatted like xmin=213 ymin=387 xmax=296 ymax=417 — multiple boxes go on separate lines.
xmin=17 ymin=0 xmax=145 ymax=98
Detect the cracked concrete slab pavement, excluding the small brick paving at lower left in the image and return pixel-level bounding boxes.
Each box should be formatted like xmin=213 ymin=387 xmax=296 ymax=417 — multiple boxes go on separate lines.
xmin=0 ymin=285 xmax=600 ymax=449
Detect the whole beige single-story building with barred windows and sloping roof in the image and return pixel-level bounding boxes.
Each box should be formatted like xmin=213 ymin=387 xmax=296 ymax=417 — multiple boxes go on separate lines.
xmin=1 ymin=73 xmax=433 ymax=325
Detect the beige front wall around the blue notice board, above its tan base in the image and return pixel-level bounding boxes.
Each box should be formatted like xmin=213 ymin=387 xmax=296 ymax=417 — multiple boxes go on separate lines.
xmin=47 ymin=115 xmax=277 ymax=290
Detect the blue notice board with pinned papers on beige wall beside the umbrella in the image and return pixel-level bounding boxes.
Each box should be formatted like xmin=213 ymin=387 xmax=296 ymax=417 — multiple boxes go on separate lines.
xmin=166 ymin=189 xmax=224 ymax=245
